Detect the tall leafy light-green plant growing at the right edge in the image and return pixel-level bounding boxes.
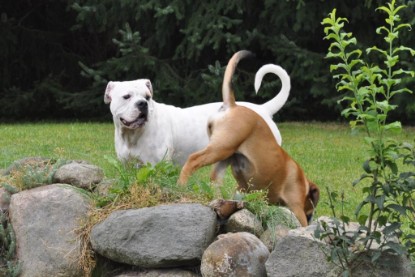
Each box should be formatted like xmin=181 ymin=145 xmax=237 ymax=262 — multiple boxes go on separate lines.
xmin=322 ymin=0 xmax=415 ymax=272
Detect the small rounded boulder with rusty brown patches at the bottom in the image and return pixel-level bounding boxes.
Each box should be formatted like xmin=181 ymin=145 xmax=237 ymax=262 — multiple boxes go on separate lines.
xmin=200 ymin=232 xmax=274 ymax=277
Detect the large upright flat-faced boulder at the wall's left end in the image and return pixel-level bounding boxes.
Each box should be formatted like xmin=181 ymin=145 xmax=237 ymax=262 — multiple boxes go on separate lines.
xmin=9 ymin=184 xmax=91 ymax=277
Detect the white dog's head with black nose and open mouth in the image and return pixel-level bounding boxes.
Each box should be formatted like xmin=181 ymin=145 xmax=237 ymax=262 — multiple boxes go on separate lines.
xmin=104 ymin=79 xmax=153 ymax=129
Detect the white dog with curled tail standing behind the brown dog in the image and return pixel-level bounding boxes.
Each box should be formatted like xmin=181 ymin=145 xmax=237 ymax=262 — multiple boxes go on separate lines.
xmin=104 ymin=56 xmax=290 ymax=166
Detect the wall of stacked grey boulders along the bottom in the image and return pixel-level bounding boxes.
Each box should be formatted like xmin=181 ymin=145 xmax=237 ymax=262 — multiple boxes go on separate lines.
xmin=0 ymin=156 xmax=412 ymax=277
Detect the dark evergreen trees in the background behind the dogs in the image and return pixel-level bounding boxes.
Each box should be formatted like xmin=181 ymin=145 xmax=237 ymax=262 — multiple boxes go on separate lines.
xmin=0 ymin=0 xmax=415 ymax=125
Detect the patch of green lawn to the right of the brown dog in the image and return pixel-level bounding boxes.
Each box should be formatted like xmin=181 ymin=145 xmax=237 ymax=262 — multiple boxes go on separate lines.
xmin=278 ymin=123 xmax=415 ymax=219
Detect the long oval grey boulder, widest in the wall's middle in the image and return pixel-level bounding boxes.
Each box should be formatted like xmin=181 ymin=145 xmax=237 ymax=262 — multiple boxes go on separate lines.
xmin=91 ymin=204 xmax=217 ymax=268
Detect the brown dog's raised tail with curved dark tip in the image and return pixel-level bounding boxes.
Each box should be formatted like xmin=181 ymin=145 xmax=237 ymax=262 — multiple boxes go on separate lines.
xmin=222 ymin=50 xmax=254 ymax=109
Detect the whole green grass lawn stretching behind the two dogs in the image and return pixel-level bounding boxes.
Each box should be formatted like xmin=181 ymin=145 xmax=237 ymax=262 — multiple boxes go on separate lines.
xmin=0 ymin=123 xmax=415 ymax=216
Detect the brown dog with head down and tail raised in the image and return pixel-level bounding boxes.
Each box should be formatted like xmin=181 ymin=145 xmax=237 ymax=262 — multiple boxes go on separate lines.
xmin=178 ymin=51 xmax=319 ymax=226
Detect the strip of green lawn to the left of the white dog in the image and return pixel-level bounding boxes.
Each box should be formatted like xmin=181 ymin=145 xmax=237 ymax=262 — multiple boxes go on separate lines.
xmin=0 ymin=123 xmax=116 ymax=176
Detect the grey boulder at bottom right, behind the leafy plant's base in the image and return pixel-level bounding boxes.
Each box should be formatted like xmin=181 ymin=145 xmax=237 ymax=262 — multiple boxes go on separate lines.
xmin=266 ymin=217 xmax=411 ymax=277
